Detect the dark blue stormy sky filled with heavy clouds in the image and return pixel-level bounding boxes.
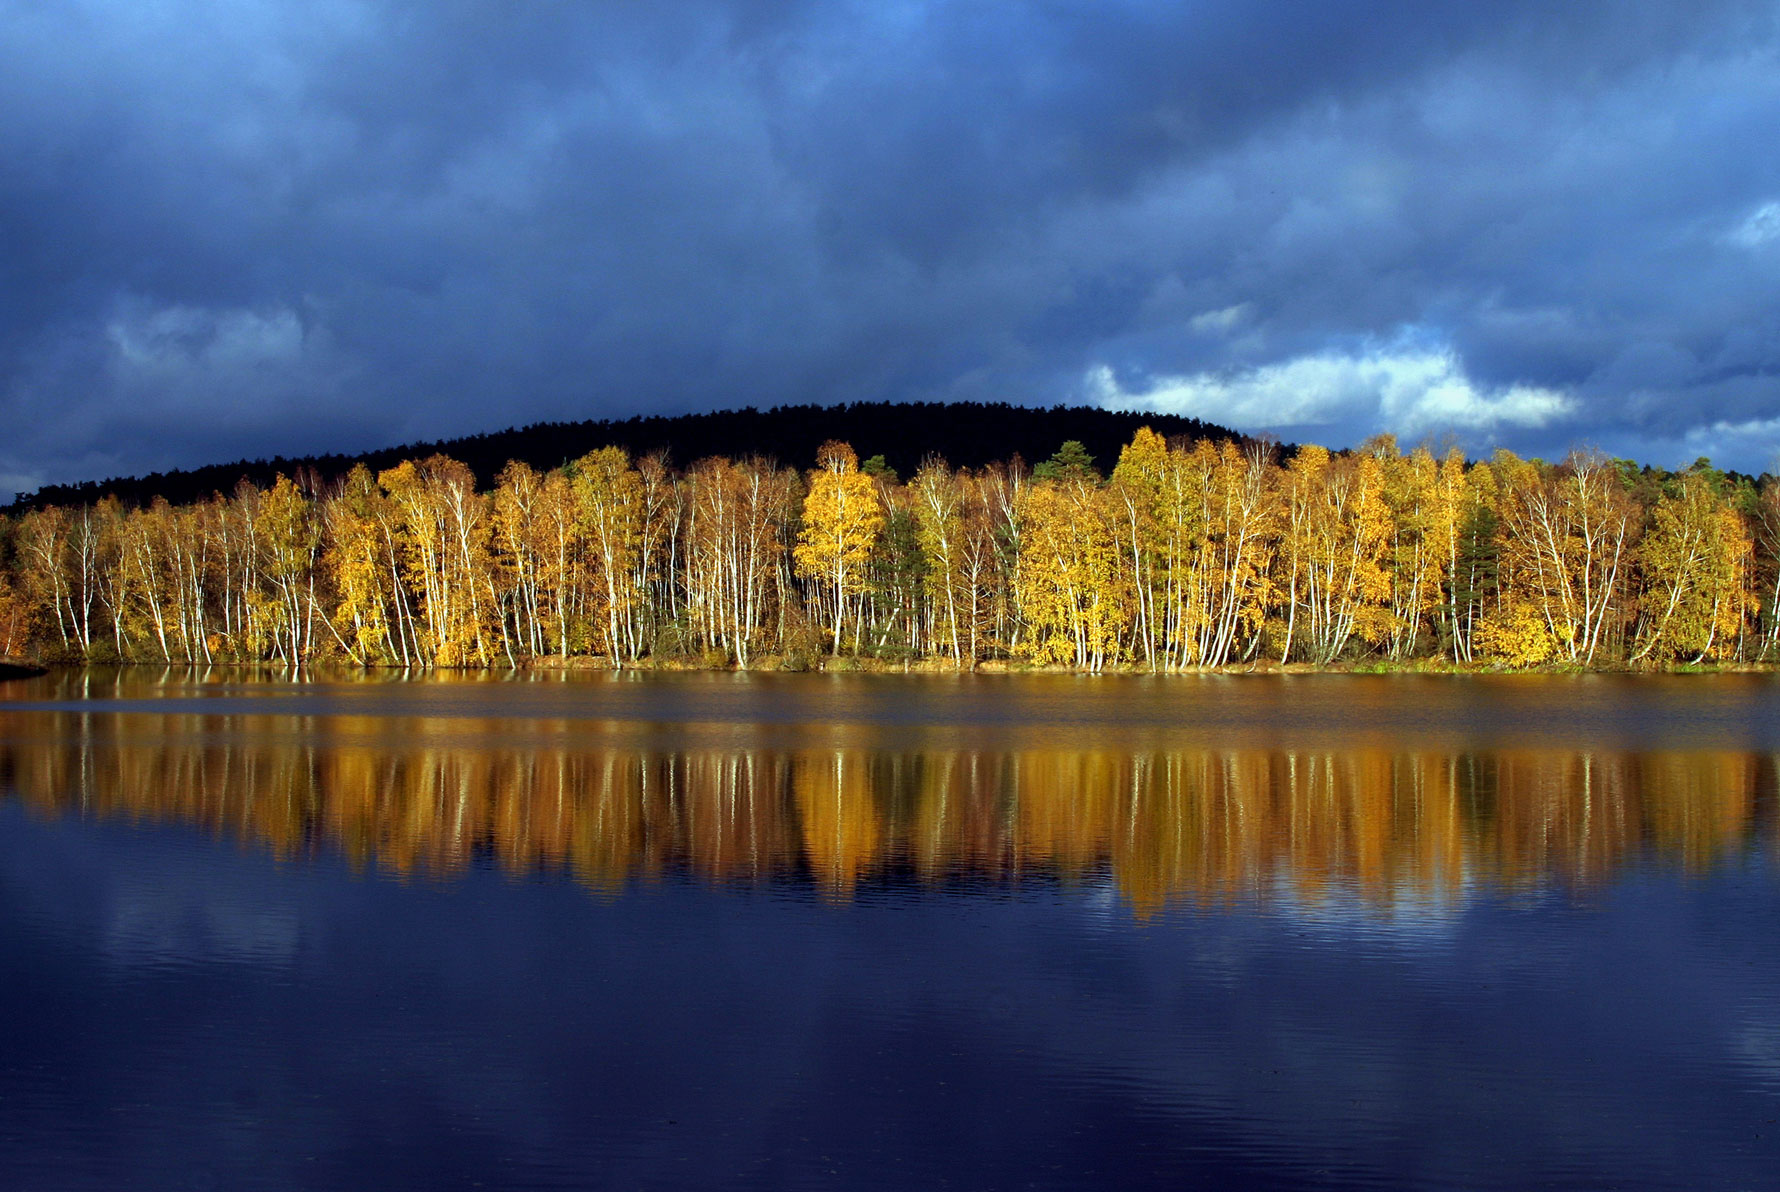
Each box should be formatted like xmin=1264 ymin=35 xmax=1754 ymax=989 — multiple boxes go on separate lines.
xmin=0 ymin=0 xmax=1780 ymax=498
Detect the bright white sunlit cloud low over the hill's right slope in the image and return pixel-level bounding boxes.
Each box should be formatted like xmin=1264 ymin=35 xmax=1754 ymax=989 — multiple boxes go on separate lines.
xmin=1086 ymin=342 xmax=1575 ymax=436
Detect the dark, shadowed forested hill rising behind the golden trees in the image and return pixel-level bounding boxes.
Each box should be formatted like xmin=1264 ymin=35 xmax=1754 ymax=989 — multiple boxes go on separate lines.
xmin=12 ymin=402 xmax=1241 ymax=511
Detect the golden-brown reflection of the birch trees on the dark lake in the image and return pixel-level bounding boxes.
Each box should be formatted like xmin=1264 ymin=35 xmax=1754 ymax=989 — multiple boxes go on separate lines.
xmin=0 ymin=712 xmax=1776 ymax=914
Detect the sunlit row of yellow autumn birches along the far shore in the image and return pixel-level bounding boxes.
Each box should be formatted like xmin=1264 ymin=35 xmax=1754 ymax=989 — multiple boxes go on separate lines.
xmin=0 ymin=429 xmax=1780 ymax=671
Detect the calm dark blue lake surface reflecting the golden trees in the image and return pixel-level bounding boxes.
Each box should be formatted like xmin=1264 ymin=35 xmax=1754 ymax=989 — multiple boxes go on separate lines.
xmin=0 ymin=671 xmax=1780 ymax=1188
